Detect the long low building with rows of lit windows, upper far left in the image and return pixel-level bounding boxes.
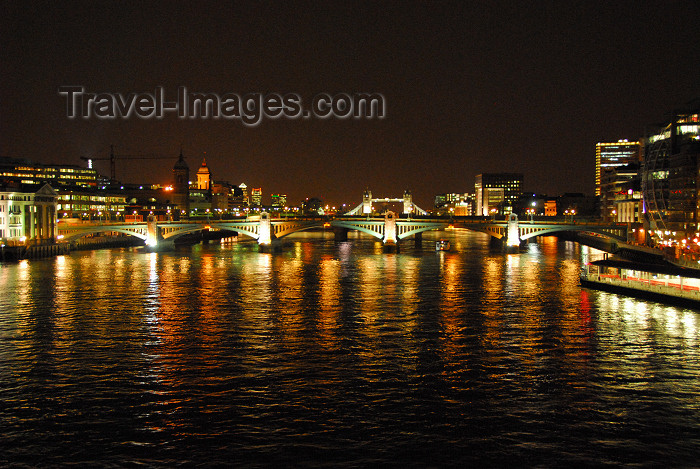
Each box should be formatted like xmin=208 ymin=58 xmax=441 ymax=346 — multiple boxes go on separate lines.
xmin=0 ymin=156 xmax=99 ymax=187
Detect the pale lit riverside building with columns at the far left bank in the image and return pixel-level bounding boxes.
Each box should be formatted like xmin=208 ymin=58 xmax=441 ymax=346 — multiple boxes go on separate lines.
xmin=0 ymin=184 xmax=57 ymax=245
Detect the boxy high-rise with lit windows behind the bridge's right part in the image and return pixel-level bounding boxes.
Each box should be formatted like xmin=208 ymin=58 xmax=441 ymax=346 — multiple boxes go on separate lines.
xmin=474 ymin=173 xmax=523 ymax=216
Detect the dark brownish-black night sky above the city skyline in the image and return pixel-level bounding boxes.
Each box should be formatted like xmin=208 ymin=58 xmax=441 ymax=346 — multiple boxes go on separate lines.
xmin=0 ymin=1 xmax=700 ymax=208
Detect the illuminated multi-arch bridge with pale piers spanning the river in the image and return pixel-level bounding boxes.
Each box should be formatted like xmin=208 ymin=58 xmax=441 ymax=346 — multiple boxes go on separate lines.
xmin=57 ymin=212 xmax=628 ymax=250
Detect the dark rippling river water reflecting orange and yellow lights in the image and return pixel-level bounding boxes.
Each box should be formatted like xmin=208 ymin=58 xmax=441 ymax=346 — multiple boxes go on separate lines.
xmin=0 ymin=231 xmax=700 ymax=467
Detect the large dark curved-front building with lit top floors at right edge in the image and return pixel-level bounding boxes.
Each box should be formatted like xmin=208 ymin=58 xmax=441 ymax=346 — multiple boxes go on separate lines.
xmin=641 ymin=100 xmax=700 ymax=236
